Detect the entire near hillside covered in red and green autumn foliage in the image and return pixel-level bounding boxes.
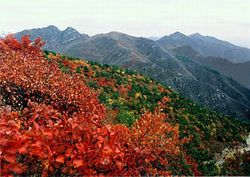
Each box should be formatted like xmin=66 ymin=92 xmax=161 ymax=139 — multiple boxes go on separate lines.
xmin=0 ymin=38 xmax=250 ymax=176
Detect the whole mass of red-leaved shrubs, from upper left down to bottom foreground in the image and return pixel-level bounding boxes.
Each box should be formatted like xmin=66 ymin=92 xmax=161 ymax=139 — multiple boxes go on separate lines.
xmin=0 ymin=36 xmax=199 ymax=176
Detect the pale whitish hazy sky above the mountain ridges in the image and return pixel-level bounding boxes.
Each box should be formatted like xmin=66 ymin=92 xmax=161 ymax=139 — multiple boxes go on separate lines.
xmin=0 ymin=0 xmax=250 ymax=48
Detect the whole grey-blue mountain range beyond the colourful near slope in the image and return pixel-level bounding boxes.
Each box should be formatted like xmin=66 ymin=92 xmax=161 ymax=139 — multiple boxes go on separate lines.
xmin=15 ymin=26 xmax=250 ymax=119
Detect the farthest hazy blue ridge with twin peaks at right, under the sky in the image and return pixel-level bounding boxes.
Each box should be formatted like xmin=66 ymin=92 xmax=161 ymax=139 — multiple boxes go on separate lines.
xmin=157 ymin=32 xmax=250 ymax=63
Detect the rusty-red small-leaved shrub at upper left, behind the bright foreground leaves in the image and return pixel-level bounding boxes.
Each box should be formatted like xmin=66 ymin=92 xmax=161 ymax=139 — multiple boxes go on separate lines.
xmin=0 ymin=34 xmax=104 ymax=121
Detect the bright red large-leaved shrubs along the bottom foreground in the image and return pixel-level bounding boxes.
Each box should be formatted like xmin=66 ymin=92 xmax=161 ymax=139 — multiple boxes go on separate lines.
xmin=0 ymin=103 xmax=184 ymax=176
